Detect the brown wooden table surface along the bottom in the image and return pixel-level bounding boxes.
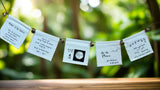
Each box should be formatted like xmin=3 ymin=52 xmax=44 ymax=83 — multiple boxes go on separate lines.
xmin=0 ymin=78 xmax=160 ymax=90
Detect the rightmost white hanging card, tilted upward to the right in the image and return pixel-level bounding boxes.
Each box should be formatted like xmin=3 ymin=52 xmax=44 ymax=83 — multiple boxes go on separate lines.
xmin=123 ymin=30 xmax=153 ymax=61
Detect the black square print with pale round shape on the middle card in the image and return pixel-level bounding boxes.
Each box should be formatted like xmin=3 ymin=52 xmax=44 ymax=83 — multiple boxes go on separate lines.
xmin=73 ymin=49 xmax=86 ymax=62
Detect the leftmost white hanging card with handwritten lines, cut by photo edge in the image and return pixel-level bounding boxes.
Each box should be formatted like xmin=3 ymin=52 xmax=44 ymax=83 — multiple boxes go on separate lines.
xmin=0 ymin=15 xmax=31 ymax=49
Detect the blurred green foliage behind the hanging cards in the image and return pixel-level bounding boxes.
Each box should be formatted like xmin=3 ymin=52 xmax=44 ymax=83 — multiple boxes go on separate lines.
xmin=0 ymin=0 xmax=160 ymax=80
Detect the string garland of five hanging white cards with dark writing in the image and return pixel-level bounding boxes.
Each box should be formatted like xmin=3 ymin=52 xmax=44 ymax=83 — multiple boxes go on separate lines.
xmin=0 ymin=1 xmax=153 ymax=67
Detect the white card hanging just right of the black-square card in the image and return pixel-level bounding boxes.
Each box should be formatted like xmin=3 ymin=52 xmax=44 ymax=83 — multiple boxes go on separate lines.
xmin=95 ymin=40 xmax=122 ymax=67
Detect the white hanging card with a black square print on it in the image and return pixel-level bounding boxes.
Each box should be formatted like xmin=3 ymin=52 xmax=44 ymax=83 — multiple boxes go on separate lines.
xmin=63 ymin=38 xmax=90 ymax=66
